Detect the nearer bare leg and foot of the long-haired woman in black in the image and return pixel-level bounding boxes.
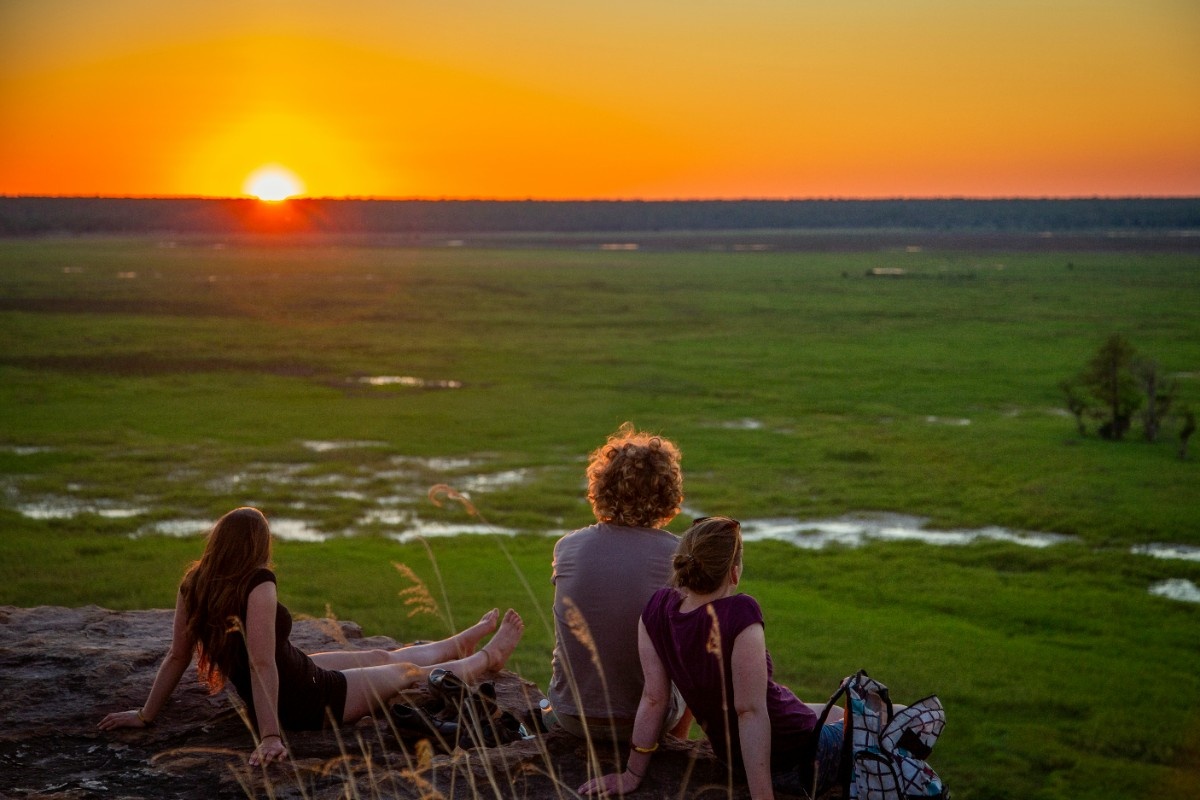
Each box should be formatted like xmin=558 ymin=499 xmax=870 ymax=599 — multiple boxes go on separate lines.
xmin=342 ymin=608 xmax=524 ymax=722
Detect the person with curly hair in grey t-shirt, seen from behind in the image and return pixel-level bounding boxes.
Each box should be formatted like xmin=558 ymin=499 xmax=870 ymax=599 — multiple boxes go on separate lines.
xmin=547 ymin=422 xmax=690 ymax=742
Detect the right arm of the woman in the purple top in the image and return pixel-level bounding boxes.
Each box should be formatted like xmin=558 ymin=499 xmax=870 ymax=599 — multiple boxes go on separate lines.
xmin=733 ymin=625 xmax=775 ymax=800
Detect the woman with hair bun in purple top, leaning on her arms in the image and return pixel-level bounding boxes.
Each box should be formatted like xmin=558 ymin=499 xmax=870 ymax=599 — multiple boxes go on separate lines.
xmin=580 ymin=517 xmax=842 ymax=800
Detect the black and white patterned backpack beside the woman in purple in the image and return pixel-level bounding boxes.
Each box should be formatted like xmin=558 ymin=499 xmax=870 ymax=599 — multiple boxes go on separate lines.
xmin=816 ymin=669 xmax=950 ymax=800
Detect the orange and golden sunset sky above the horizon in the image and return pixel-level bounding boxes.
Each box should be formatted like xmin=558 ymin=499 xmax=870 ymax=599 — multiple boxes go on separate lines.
xmin=0 ymin=0 xmax=1200 ymax=199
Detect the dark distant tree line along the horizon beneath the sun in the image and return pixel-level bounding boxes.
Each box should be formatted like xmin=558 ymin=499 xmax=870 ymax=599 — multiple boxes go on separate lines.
xmin=0 ymin=197 xmax=1200 ymax=236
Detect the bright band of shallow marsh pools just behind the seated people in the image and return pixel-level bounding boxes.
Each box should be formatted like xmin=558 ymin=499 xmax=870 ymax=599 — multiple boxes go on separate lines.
xmin=5 ymin=441 xmax=1200 ymax=603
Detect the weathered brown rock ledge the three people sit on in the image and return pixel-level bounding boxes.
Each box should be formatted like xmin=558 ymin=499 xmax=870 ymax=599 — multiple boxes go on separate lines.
xmin=0 ymin=606 xmax=768 ymax=800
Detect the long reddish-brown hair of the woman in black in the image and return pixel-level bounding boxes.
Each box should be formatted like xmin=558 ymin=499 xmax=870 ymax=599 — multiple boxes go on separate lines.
xmin=179 ymin=506 xmax=271 ymax=693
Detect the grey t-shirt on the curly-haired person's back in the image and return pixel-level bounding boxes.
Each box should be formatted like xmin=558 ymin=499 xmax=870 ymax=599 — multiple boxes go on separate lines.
xmin=547 ymin=523 xmax=678 ymax=721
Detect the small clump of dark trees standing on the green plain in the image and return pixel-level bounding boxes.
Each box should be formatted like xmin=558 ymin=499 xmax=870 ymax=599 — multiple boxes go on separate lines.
xmin=1058 ymin=333 xmax=1196 ymax=458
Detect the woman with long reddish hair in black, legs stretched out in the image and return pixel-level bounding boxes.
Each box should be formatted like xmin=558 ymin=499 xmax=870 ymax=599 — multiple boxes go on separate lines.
xmin=100 ymin=507 xmax=524 ymax=764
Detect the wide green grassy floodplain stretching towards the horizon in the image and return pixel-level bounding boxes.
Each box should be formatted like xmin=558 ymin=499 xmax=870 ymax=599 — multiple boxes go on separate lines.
xmin=0 ymin=237 xmax=1200 ymax=800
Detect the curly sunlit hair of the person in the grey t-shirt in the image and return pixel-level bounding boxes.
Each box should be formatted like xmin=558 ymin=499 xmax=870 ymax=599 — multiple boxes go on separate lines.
xmin=588 ymin=422 xmax=683 ymax=528
